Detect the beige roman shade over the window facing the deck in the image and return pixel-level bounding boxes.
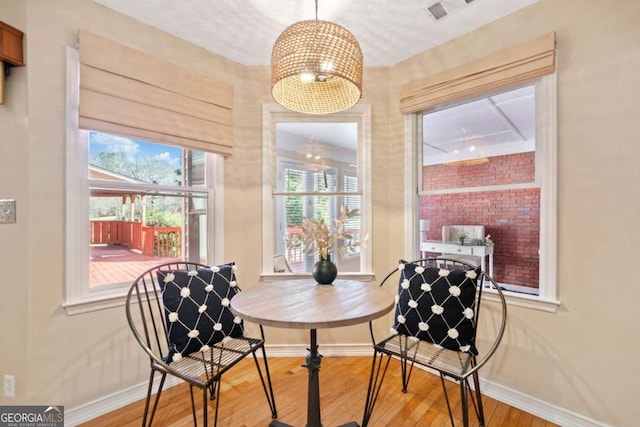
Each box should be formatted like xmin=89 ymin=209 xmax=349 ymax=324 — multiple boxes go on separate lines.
xmin=79 ymin=30 xmax=233 ymax=155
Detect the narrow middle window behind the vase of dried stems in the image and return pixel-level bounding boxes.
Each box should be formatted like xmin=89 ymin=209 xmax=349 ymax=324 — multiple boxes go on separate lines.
xmin=263 ymin=106 xmax=371 ymax=277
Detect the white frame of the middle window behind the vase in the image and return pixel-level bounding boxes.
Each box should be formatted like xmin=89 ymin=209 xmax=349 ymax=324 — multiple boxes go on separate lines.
xmin=261 ymin=104 xmax=374 ymax=281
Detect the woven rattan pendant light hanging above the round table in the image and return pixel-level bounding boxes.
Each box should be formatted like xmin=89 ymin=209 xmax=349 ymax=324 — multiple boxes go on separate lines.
xmin=271 ymin=0 xmax=362 ymax=114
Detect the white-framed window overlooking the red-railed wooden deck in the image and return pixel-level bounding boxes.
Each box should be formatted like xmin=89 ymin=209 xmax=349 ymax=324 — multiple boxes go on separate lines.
xmin=63 ymin=49 xmax=222 ymax=314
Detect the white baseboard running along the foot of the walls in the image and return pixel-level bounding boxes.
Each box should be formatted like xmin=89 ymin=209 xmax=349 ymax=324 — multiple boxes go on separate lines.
xmin=64 ymin=344 xmax=609 ymax=427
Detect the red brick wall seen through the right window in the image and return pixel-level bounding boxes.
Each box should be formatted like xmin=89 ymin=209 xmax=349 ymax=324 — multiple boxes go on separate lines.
xmin=420 ymin=153 xmax=540 ymax=288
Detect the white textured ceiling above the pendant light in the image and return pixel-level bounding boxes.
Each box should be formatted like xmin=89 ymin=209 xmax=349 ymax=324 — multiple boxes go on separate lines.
xmin=94 ymin=0 xmax=538 ymax=66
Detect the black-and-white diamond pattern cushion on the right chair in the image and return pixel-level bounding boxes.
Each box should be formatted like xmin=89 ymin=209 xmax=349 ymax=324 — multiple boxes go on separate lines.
xmin=392 ymin=261 xmax=480 ymax=355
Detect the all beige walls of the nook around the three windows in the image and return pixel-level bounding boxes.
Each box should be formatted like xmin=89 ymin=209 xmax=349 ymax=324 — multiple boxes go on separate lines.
xmin=0 ymin=0 xmax=640 ymax=426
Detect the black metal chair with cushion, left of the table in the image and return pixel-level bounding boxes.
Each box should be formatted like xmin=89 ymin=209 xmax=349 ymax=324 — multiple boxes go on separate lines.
xmin=126 ymin=262 xmax=277 ymax=426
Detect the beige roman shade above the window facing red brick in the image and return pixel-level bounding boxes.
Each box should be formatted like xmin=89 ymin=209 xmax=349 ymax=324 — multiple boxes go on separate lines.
xmin=400 ymin=33 xmax=555 ymax=114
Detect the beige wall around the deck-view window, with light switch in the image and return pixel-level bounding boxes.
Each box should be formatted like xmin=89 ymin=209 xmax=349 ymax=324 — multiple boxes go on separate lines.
xmin=0 ymin=0 xmax=248 ymax=408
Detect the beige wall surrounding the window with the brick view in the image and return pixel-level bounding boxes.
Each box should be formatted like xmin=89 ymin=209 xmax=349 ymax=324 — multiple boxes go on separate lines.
xmin=389 ymin=0 xmax=640 ymax=426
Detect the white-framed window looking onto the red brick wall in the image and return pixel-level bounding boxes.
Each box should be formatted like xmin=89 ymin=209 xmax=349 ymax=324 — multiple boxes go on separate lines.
xmin=412 ymin=75 xmax=556 ymax=310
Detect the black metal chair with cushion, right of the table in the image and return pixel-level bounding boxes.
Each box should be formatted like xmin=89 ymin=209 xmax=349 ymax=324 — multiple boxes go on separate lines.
xmin=362 ymin=257 xmax=507 ymax=427
